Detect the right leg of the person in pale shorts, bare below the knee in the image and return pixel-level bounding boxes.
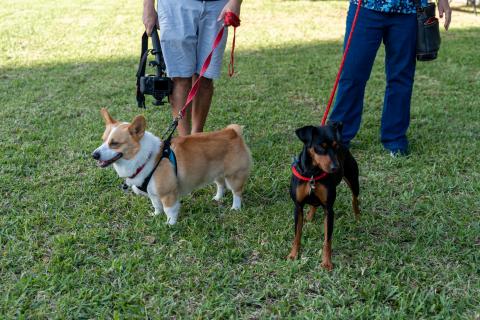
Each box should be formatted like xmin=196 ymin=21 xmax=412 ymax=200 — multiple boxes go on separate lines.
xmin=192 ymin=0 xmax=227 ymax=133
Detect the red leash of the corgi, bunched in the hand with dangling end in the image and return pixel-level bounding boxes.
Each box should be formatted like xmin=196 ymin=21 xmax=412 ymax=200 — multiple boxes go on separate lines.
xmin=178 ymin=11 xmax=240 ymax=118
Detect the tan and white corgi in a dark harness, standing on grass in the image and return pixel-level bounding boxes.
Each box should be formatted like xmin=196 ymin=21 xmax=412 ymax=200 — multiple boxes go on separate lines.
xmin=92 ymin=108 xmax=252 ymax=225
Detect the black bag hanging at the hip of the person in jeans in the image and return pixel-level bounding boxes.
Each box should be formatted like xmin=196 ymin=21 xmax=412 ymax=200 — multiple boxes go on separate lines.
xmin=414 ymin=0 xmax=440 ymax=61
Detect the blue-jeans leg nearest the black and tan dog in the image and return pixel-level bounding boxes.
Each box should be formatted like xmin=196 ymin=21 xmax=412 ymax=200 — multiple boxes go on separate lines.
xmin=329 ymin=4 xmax=384 ymax=146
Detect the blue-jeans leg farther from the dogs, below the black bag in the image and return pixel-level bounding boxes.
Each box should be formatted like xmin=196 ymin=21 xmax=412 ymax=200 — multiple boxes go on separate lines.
xmin=381 ymin=14 xmax=417 ymax=153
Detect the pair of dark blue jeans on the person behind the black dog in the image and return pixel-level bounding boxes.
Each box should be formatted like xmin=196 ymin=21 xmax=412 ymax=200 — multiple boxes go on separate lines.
xmin=330 ymin=4 xmax=417 ymax=150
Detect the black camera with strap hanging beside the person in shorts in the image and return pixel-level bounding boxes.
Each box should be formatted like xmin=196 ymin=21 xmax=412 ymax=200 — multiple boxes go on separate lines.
xmin=137 ymin=29 xmax=173 ymax=108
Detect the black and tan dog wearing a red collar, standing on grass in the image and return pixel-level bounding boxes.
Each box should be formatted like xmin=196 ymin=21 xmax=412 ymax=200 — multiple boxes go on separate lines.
xmin=287 ymin=123 xmax=360 ymax=270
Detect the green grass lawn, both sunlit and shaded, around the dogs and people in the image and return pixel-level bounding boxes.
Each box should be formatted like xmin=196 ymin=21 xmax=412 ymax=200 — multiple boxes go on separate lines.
xmin=0 ymin=0 xmax=480 ymax=319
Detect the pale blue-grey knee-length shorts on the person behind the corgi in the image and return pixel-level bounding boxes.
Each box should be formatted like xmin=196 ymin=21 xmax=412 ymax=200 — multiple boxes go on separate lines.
xmin=158 ymin=0 xmax=228 ymax=79
